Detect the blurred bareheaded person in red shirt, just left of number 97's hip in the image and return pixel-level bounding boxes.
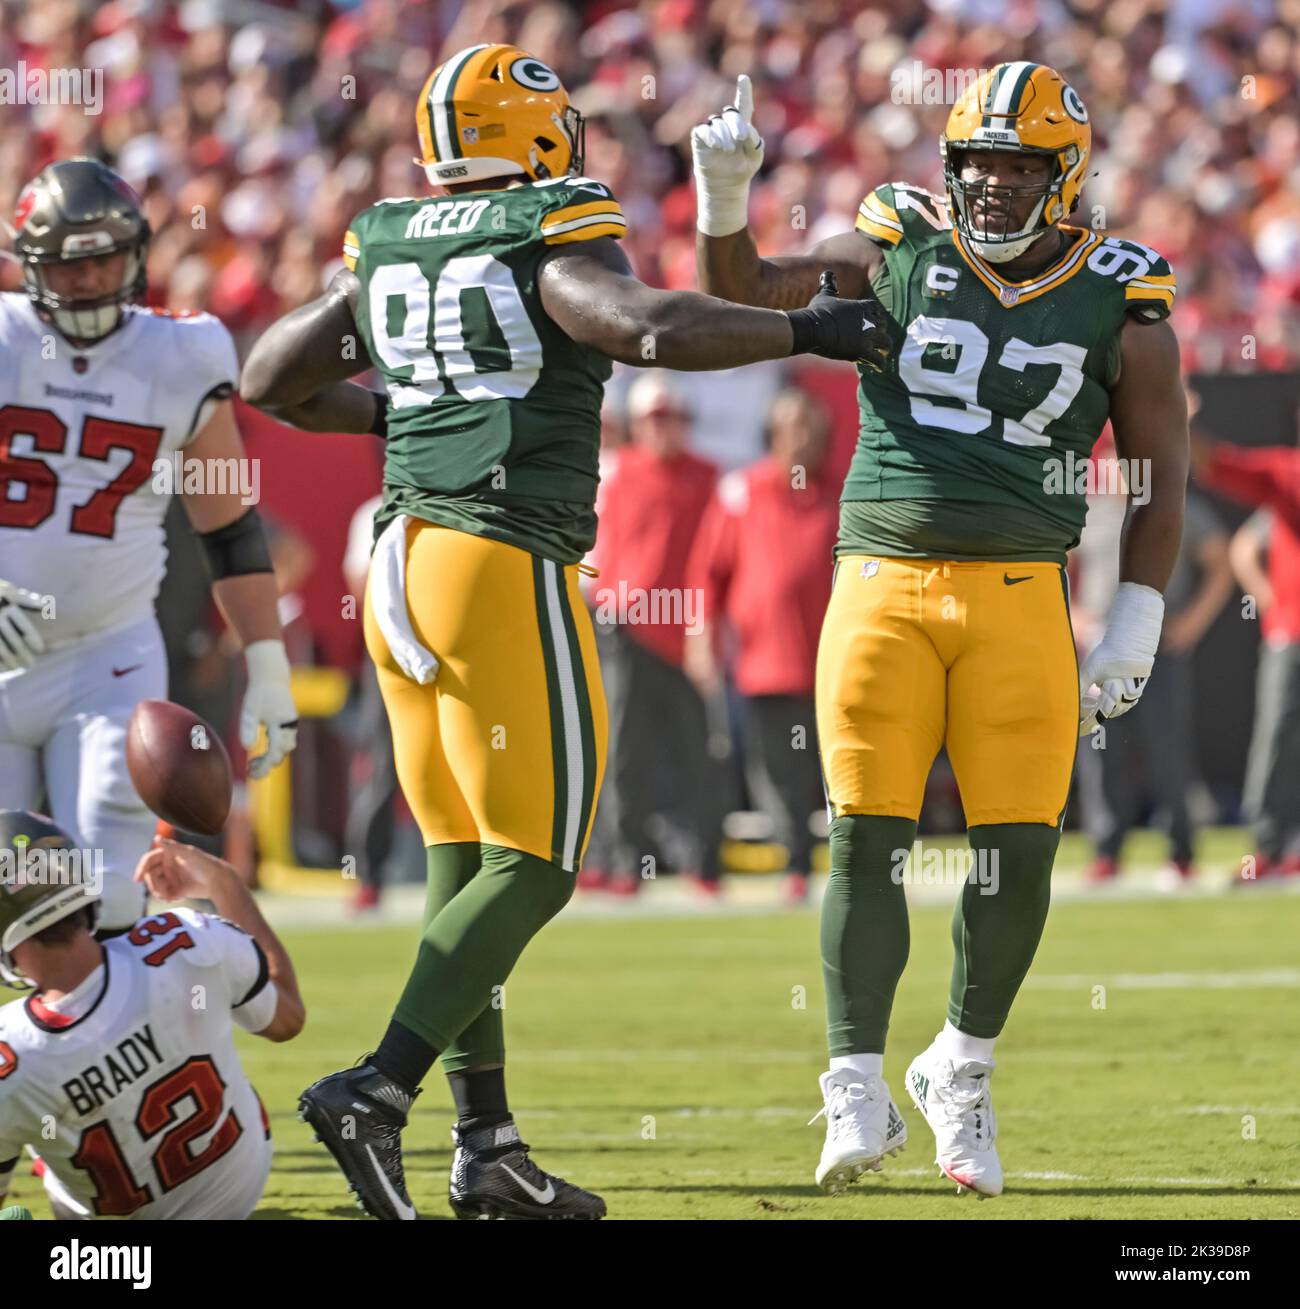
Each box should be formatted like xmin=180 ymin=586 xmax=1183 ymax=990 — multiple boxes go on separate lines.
xmin=686 ymin=390 xmax=839 ymax=901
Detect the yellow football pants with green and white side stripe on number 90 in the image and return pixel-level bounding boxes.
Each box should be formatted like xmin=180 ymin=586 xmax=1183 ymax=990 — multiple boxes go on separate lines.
xmin=365 ymin=521 xmax=607 ymax=872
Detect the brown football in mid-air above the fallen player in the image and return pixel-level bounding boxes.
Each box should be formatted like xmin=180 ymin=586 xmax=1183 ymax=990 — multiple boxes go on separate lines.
xmin=127 ymin=700 xmax=233 ymax=836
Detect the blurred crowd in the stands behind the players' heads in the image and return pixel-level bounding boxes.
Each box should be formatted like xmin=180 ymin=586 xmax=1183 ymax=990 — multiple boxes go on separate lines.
xmin=0 ymin=0 xmax=1300 ymax=372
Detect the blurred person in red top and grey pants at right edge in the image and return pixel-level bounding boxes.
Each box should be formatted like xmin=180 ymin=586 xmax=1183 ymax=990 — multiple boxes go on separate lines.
xmin=1191 ymin=428 xmax=1300 ymax=885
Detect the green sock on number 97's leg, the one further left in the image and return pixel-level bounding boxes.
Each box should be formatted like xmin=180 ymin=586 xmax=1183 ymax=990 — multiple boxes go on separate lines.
xmin=821 ymin=814 xmax=916 ymax=1055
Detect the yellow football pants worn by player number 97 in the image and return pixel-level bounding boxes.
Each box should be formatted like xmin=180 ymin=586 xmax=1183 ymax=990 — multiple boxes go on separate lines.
xmin=817 ymin=555 xmax=1079 ymax=826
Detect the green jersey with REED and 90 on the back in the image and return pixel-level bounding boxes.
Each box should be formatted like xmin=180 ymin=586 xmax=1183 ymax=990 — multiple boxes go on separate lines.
xmin=343 ymin=177 xmax=626 ymax=563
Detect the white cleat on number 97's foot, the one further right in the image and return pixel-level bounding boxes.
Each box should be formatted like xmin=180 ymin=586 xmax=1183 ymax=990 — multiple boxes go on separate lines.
xmin=907 ymin=1046 xmax=1002 ymax=1200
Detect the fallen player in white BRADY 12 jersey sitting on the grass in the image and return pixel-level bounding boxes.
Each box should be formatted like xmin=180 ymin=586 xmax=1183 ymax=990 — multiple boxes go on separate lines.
xmin=0 ymin=810 xmax=302 ymax=1219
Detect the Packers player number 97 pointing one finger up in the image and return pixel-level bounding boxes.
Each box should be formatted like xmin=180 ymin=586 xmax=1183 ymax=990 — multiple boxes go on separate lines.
xmin=693 ymin=63 xmax=1187 ymax=1196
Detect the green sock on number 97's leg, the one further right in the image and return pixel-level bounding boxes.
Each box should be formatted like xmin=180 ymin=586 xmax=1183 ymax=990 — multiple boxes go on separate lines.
xmin=948 ymin=822 xmax=1060 ymax=1038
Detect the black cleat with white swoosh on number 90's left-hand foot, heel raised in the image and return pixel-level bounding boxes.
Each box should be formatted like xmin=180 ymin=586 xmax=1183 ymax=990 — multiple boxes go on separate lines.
xmin=298 ymin=1063 xmax=419 ymax=1221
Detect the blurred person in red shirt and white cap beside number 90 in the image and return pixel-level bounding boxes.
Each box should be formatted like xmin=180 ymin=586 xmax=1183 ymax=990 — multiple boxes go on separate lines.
xmin=583 ymin=373 xmax=724 ymax=894
